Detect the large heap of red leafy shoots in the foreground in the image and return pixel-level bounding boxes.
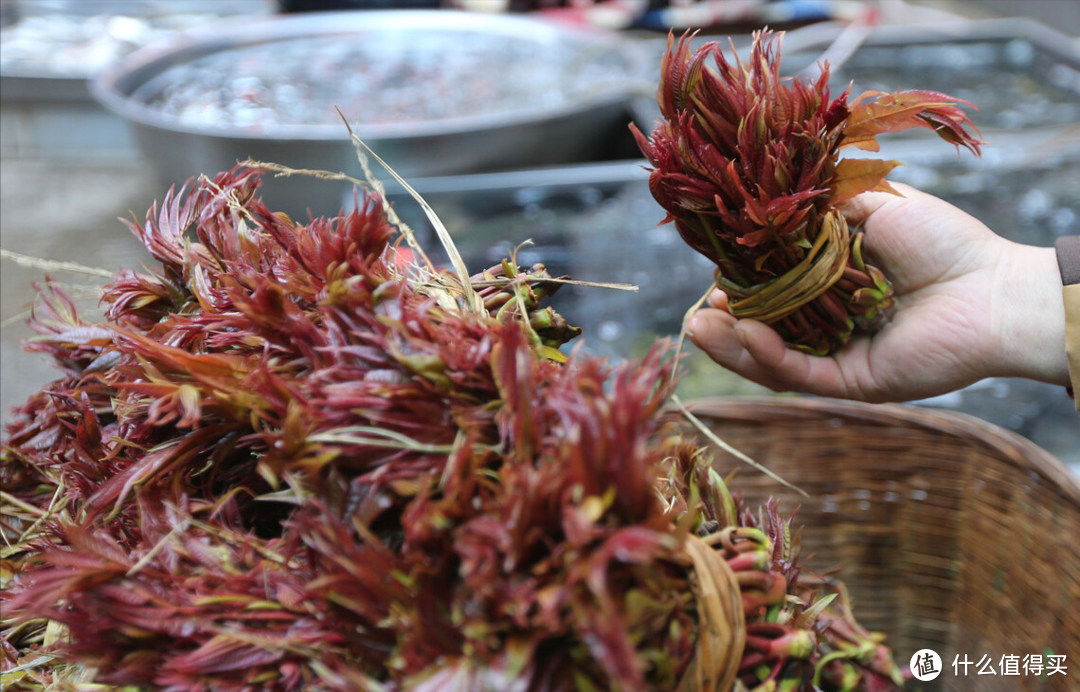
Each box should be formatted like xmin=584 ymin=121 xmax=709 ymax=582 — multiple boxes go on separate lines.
xmin=0 ymin=35 xmax=920 ymax=692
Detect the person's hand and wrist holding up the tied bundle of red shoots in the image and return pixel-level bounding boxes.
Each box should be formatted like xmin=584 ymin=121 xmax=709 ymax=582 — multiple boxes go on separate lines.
xmin=687 ymin=184 xmax=1068 ymax=402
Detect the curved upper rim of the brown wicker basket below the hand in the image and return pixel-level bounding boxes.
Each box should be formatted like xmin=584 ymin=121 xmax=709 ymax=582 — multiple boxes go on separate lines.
xmin=687 ymin=396 xmax=1080 ymax=507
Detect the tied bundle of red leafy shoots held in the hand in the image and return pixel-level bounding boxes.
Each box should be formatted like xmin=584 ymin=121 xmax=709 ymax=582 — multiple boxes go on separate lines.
xmin=631 ymin=31 xmax=983 ymax=355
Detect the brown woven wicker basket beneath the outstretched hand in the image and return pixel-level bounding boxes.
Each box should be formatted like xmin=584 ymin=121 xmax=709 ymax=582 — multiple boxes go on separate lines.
xmin=691 ymin=397 xmax=1080 ymax=692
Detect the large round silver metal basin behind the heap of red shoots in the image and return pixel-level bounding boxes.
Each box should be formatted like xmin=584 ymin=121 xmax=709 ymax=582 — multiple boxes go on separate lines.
xmin=91 ymin=11 xmax=634 ymax=215
